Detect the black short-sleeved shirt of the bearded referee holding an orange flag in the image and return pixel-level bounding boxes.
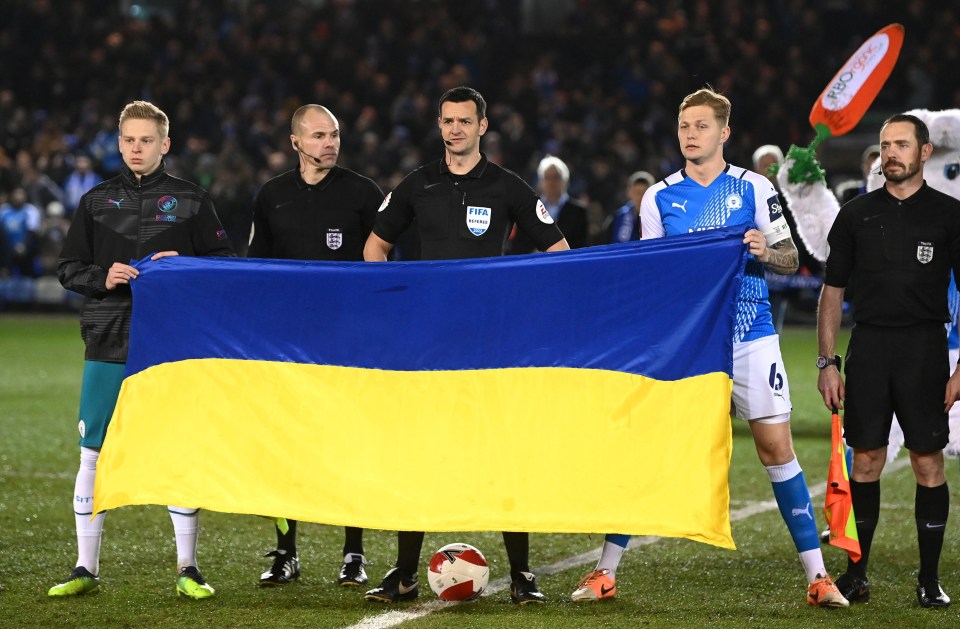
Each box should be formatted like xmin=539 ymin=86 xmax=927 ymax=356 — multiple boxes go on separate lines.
xmin=824 ymin=182 xmax=960 ymax=326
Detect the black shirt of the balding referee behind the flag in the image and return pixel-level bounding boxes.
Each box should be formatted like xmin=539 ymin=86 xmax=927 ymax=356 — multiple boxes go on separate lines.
xmin=247 ymin=166 xmax=383 ymax=261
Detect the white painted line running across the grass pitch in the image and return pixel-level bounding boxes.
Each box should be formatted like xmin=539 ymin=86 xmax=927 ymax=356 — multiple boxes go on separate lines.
xmin=346 ymin=457 xmax=910 ymax=629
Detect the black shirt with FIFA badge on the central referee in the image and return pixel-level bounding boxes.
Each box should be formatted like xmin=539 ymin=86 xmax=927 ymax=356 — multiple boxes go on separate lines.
xmin=373 ymin=154 xmax=563 ymax=260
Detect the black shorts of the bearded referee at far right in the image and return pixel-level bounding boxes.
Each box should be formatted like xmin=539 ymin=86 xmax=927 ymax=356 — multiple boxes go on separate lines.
xmin=843 ymin=323 xmax=950 ymax=454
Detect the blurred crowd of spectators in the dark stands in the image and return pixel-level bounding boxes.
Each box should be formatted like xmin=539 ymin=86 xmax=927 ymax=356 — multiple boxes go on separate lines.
xmin=0 ymin=0 xmax=960 ymax=274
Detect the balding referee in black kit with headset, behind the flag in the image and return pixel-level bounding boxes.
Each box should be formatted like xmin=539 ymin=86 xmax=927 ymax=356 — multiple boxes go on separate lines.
xmin=247 ymin=105 xmax=383 ymax=586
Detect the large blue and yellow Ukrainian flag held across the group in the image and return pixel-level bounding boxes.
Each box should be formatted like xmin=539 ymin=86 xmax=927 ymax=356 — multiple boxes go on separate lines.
xmin=94 ymin=229 xmax=746 ymax=548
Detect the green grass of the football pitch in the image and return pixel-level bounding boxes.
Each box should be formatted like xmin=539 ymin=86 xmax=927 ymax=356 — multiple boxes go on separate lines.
xmin=0 ymin=316 xmax=960 ymax=628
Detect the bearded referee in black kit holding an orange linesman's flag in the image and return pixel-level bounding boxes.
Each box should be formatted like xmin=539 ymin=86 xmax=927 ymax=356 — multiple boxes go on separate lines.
xmin=817 ymin=114 xmax=960 ymax=607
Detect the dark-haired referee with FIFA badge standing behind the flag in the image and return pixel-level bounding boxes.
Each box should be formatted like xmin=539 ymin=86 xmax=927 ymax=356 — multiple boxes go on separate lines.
xmin=363 ymin=87 xmax=570 ymax=605
